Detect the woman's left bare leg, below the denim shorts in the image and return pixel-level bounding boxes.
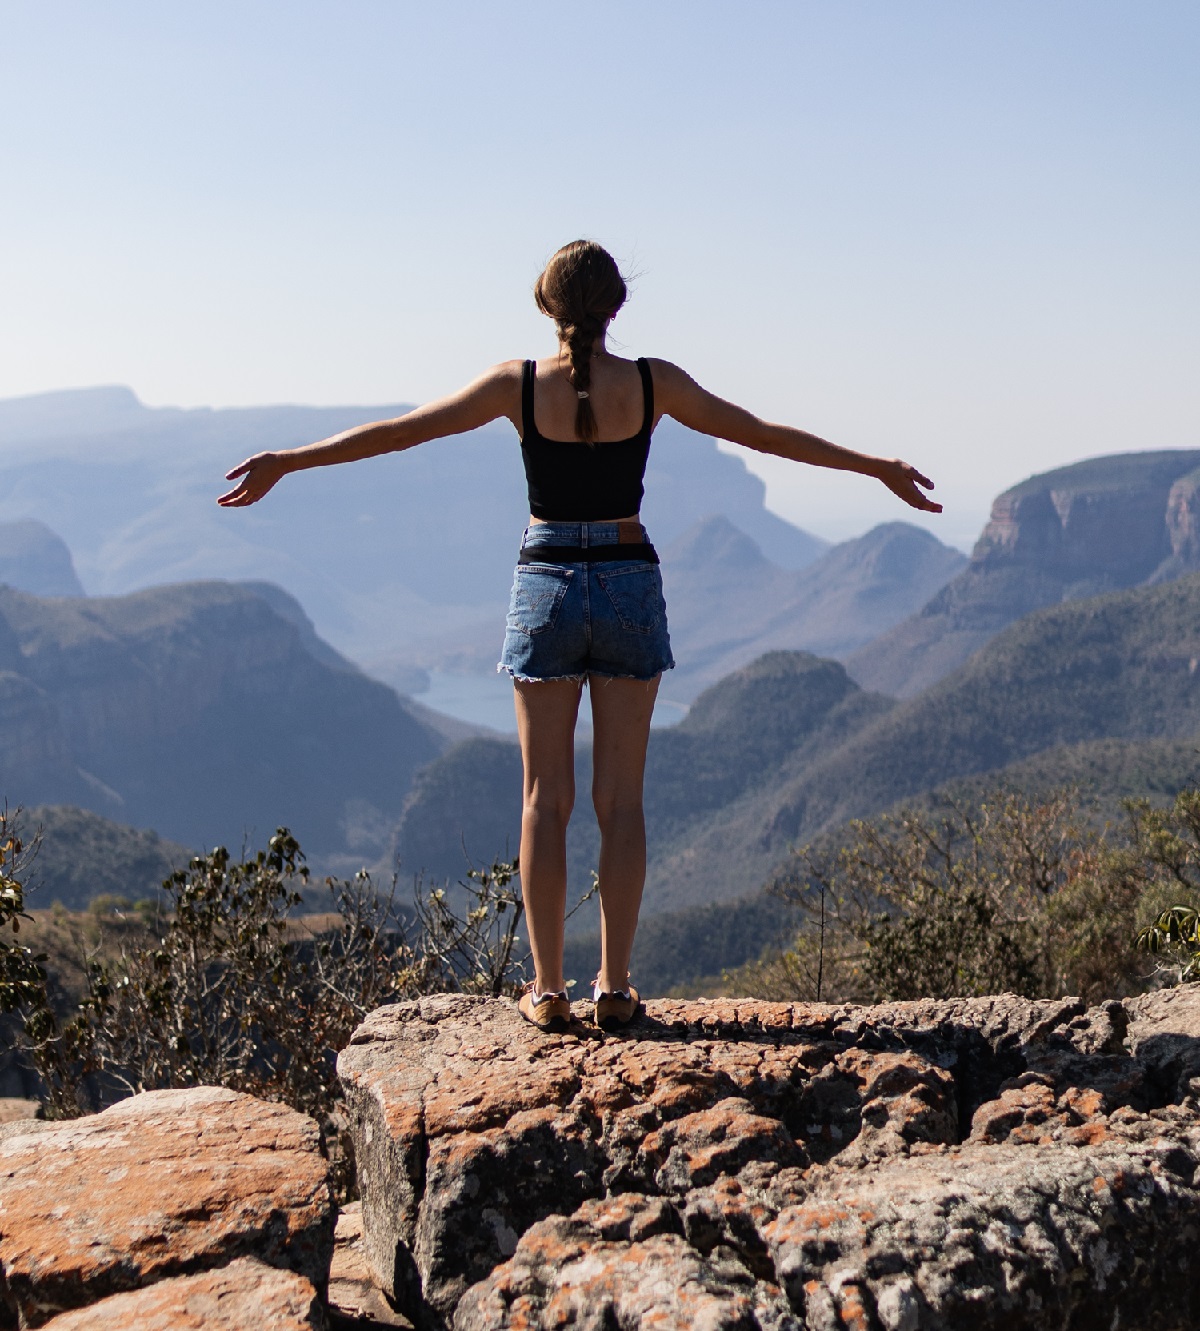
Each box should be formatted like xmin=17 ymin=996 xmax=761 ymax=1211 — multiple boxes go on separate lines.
xmin=514 ymin=679 xmax=583 ymax=993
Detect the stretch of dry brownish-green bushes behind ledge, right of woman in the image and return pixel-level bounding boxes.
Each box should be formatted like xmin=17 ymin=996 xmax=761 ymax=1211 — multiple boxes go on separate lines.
xmin=728 ymin=789 xmax=1200 ymax=1002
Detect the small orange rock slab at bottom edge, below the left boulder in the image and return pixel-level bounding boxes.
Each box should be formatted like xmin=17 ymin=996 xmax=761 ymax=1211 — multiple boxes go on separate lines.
xmin=45 ymin=1256 xmax=327 ymax=1331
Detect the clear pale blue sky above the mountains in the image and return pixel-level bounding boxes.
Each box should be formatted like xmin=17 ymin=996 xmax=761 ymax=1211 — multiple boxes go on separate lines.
xmin=0 ymin=0 xmax=1200 ymax=546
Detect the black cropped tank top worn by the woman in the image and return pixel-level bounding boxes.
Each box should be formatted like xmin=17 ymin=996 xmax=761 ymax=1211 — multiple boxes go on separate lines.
xmin=520 ymin=359 xmax=655 ymax=522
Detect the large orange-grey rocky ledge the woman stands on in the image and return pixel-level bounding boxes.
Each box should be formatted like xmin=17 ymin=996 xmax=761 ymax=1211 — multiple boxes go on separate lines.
xmin=339 ymin=988 xmax=1200 ymax=1331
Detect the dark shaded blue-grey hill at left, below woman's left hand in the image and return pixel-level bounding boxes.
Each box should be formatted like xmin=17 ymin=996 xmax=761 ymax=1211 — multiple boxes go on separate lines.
xmin=0 ymin=583 xmax=447 ymax=862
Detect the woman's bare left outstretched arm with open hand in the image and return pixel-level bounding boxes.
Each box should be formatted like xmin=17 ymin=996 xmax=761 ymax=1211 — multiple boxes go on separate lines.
xmin=217 ymin=361 xmax=522 ymax=508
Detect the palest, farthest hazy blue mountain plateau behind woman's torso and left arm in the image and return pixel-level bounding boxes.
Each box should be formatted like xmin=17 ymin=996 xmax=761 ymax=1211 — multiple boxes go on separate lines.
xmin=0 ymin=387 xmax=826 ymax=680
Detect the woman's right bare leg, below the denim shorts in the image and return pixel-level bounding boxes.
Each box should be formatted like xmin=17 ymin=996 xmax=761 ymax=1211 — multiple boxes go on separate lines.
xmin=588 ymin=675 xmax=659 ymax=993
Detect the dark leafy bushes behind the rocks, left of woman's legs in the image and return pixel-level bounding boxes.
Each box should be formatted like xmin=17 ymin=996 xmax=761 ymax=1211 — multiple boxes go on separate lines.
xmin=16 ymin=828 xmax=524 ymax=1195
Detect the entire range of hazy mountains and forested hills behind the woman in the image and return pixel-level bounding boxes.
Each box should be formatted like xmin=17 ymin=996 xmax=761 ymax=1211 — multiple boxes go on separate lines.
xmin=0 ymin=380 xmax=1200 ymax=984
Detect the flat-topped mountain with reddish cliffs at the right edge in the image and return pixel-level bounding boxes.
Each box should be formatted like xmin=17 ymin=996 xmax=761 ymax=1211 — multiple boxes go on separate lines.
xmin=847 ymin=450 xmax=1200 ymax=697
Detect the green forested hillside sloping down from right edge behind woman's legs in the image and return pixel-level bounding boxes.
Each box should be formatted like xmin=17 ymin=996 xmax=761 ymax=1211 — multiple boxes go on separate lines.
xmin=396 ymin=576 xmax=1200 ymax=937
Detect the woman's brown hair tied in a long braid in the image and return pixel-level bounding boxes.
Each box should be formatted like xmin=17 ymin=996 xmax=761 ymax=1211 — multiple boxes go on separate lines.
xmin=533 ymin=241 xmax=627 ymax=443
